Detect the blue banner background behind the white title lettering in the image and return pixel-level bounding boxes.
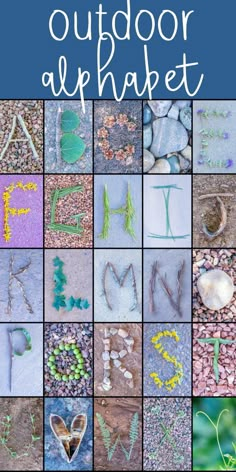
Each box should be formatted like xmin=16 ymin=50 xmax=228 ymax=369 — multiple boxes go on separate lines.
xmin=0 ymin=0 xmax=236 ymax=98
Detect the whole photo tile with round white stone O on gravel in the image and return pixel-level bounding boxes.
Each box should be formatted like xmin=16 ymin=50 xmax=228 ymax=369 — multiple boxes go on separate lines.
xmin=193 ymin=249 xmax=236 ymax=322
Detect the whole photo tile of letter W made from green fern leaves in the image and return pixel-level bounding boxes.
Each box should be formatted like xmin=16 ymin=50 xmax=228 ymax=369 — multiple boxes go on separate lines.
xmin=94 ymin=397 xmax=143 ymax=470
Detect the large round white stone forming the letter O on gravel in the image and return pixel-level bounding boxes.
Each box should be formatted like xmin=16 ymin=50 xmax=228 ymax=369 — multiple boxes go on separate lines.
xmin=197 ymin=269 xmax=234 ymax=310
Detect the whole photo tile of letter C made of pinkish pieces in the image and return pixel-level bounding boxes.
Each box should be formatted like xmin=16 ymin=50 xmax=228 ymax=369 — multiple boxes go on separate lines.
xmin=94 ymin=100 xmax=142 ymax=174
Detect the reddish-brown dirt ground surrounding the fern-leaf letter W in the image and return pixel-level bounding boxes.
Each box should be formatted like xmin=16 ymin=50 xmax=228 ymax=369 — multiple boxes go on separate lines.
xmin=94 ymin=398 xmax=142 ymax=471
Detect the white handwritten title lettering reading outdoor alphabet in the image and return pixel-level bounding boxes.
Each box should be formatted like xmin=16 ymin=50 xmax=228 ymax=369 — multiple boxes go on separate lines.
xmin=42 ymin=0 xmax=204 ymax=107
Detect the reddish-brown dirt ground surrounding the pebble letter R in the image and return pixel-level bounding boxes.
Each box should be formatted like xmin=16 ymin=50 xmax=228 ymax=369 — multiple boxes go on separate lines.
xmin=94 ymin=323 xmax=142 ymax=397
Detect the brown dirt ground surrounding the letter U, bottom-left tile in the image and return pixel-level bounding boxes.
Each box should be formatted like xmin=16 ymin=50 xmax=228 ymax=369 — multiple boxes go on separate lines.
xmin=0 ymin=398 xmax=43 ymax=470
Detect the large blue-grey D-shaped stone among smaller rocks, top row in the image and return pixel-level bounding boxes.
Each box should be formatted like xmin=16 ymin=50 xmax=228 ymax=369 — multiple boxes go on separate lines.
xmin=150 ymin=118 xmax=188 ymax=157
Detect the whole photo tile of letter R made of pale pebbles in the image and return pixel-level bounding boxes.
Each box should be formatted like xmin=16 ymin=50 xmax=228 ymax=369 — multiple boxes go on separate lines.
xmin=94 ymin=323 xmax=142 ymax=397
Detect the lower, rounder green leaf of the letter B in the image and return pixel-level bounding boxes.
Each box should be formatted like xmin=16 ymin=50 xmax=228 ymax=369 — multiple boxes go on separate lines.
xmin=60 ymin=133 xmax=86 ymax=164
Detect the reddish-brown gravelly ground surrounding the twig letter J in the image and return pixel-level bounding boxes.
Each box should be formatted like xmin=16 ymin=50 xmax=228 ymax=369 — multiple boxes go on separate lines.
xmin=193 ymin=175 xmax=236 ymax=248
